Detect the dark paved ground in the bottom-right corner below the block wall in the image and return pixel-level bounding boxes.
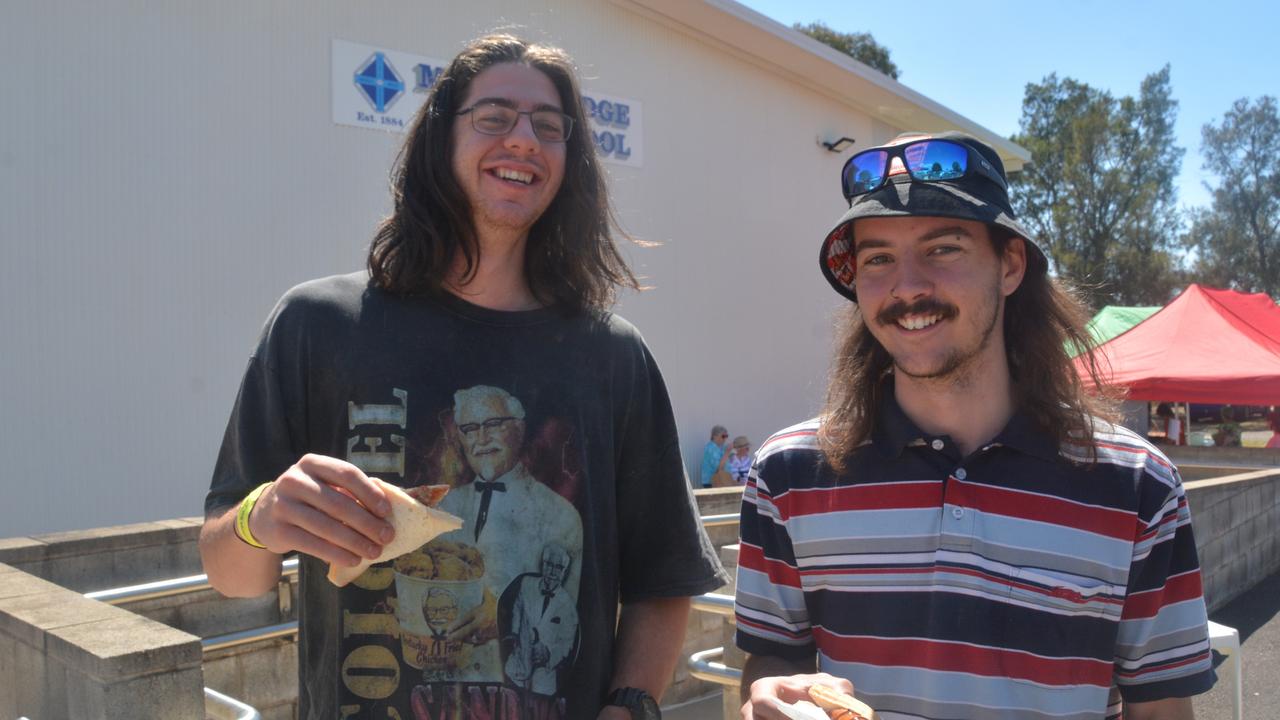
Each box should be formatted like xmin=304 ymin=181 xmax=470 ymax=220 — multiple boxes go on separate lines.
xmin=1194 ymin=573 xmax=1280 ymax=720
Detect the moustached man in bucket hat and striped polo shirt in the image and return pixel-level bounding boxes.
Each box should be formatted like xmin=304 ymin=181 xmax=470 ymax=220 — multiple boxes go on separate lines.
xmin=736 ymin=133 xmax=1213 ymax=720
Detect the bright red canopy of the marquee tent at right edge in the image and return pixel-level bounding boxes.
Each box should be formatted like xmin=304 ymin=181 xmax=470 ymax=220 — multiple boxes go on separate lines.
xmin=1076 ymin=284 xmax=1280 ymax=405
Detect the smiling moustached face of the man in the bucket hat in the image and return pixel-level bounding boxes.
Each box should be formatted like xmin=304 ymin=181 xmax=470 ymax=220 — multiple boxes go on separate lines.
xmin=854 ymin=217 xmax=1027 ymax=382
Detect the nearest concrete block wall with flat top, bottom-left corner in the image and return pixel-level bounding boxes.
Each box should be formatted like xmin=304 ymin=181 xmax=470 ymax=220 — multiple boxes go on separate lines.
xmin=0 ymin=565 xmax=205 ymax=720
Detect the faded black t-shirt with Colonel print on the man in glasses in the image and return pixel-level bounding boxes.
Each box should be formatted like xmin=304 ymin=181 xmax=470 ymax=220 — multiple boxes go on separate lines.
xmin=205 ymin=273 xmax=726 ymax=720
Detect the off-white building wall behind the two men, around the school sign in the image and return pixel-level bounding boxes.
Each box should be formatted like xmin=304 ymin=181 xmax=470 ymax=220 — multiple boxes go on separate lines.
xmin=0 ymin=0 xmax=926 ymax=537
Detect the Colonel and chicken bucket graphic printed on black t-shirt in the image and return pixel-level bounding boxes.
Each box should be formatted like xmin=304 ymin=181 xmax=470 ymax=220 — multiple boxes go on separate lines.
xmin=340 ymin=384 xmax=582 ymax=720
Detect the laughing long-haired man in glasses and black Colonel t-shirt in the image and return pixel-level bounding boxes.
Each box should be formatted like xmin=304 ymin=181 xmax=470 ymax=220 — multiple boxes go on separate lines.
xmin=201 ymin=35 xmax=723 ymax=720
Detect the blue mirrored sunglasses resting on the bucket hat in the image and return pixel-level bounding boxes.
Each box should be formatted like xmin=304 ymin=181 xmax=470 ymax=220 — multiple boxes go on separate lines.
xmin=840 ymin=138 xmax=1009 ymax=202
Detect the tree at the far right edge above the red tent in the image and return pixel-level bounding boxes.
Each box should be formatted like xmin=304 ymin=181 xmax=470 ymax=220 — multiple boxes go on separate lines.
xmin=1187 ymin=96 xmax=1280 ymax=297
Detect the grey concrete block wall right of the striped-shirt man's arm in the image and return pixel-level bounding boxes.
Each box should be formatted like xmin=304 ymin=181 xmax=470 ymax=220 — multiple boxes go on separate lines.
xmin=1185 ymin=468 xmax=1280 ymax=612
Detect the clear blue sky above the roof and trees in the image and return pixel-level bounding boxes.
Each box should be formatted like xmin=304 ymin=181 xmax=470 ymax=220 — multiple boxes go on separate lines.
xmin=739 ymin=0 xmax=1280 ymax=205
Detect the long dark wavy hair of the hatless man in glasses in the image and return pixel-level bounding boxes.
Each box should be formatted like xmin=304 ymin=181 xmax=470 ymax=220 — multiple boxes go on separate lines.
xmin=367 ymin=33 xmax=639 ymax=313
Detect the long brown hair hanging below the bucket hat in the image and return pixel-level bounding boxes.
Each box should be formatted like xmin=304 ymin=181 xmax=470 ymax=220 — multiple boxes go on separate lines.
xmin=818 ymin=225 xmax=1116 ymax=473
